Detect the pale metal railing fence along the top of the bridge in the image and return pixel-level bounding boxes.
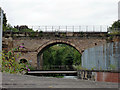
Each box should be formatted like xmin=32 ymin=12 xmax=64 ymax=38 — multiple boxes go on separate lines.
xmin=28 ymin=25 xmax=109 ymax=32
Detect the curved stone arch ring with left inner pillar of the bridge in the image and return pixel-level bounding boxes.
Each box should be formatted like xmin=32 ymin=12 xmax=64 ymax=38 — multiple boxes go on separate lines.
xmin=37 ymin=40 xmax=82 ymax=70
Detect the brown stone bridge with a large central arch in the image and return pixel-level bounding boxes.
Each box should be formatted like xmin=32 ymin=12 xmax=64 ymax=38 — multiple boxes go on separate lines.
xmin=3 ymin=32 xmax=107 ymax=69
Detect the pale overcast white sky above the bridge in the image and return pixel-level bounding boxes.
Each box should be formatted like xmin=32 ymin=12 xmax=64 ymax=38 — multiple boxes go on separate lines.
xmin=0 ymin=0 xmax=119 ymax=26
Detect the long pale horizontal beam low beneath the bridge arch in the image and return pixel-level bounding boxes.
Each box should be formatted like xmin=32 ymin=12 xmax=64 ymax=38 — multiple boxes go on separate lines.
xmin=28 ymin=71 xmax=77 ymax=74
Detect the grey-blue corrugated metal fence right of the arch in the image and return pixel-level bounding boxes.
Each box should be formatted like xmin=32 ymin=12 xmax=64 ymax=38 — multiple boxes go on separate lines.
xmin=82 ymin=42 xmax=120 ymax=70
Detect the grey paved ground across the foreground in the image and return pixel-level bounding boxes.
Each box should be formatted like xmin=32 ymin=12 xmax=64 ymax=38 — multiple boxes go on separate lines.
xmin=2 ymin=73 xmax=118 ymax=88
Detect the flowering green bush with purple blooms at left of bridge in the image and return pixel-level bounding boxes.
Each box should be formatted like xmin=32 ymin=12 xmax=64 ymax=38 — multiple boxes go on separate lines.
xmin=0 ymin=49 xmax=28 ymax=73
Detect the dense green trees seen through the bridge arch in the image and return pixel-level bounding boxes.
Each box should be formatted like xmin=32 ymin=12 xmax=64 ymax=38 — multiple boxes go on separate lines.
xmin=43 ymin=44 xmax=81 ymax=69
